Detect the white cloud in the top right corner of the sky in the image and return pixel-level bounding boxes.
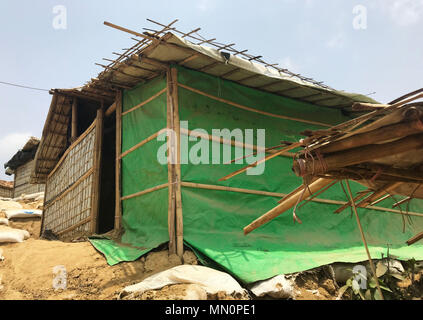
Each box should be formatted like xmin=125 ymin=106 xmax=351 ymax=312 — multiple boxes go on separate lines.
xmin=379 ymin=0 xmax=423 ymax=27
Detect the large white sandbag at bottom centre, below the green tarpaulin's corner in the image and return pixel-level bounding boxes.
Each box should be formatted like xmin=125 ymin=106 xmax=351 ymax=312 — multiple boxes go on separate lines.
xmin=119 ymin=265 xmax=247 ymax=298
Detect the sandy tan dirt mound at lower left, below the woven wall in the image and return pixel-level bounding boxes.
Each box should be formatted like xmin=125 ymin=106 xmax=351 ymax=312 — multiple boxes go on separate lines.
xmin=0 ymin=239 xmax=202 ymax=300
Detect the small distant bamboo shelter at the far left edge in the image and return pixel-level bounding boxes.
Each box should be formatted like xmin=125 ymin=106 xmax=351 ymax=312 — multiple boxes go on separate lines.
xmin=4 ymin=137 xmax=45 ymax=198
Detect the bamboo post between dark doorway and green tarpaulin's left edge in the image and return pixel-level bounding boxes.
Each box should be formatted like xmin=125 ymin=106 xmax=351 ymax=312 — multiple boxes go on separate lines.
xmin=114 ymin=90 xmax=122 ymax=230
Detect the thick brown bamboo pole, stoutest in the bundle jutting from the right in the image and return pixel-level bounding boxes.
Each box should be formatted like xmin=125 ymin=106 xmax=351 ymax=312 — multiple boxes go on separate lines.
xmin=293 ymin=134 xmax=423 ymax=176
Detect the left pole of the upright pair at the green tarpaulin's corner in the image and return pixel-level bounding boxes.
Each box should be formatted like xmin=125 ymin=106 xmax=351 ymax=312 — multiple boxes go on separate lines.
xmin=166 ymin=70 xmax=176 ymax=254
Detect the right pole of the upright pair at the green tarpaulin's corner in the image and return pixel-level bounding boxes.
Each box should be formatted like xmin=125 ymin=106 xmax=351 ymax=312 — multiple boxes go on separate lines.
xmin=170 ymin=67 xmax=184 ymax=258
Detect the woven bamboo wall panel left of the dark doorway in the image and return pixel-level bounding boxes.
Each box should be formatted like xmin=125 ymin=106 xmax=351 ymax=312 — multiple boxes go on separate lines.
xmin=43 ymin=126 xmax=96 ymax=236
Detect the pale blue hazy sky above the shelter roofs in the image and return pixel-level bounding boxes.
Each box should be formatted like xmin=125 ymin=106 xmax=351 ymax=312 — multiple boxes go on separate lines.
xmin=0 ymin=0 xmax=423 ymax=180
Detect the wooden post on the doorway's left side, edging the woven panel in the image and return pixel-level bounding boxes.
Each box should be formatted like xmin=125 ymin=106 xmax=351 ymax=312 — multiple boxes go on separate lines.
xmin=91 ymin=108 xmax=104 ymax=233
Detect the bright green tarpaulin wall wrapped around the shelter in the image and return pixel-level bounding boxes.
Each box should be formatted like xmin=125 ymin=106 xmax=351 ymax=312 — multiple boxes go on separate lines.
xmin=91 ymin=66 xmax=423 ymax=283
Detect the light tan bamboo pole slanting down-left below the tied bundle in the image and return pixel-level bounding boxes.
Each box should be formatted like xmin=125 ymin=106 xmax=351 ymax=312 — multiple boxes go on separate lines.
xmin=244 ymin=178 xmax=333 ymax=235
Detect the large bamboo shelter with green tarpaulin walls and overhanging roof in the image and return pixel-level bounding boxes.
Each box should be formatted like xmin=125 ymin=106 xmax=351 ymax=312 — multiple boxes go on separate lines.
xmin=32 ymin=20 xmax=419 ymax=282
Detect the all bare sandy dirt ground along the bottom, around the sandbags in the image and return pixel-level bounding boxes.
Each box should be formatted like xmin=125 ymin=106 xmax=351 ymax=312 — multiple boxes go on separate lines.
xmin=0 ymin=214 xmax=423 ymax=300
